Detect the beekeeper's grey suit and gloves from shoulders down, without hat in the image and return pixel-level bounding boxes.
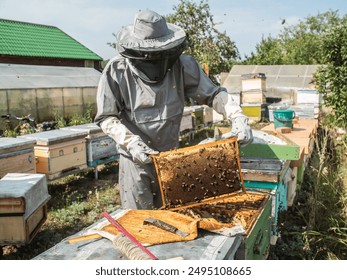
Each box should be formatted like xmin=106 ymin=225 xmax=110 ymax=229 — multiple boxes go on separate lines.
xmin=95 ymin=55 xmax=251 ymax=209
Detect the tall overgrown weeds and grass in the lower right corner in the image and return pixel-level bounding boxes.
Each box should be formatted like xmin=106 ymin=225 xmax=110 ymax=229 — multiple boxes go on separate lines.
xmin=270 ymin=126 xmax=347 ymax=259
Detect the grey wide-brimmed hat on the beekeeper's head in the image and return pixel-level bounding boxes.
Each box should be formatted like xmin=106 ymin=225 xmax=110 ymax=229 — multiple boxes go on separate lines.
xmin=117 ymin=10 xmax=186 ymax=54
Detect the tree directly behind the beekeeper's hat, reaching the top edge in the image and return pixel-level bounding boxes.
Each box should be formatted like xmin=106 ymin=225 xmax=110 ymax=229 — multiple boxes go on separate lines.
xmin=166 ymin=0 xmax=240 ymax=81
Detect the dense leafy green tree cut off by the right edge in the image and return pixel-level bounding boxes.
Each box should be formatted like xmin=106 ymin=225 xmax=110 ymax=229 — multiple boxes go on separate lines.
xmin=315 ymin=16 xmax=347 ymax=127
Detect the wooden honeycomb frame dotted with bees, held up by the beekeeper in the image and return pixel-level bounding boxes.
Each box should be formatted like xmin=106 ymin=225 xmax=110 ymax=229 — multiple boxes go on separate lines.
xmin=153 ymin=137 xmax=245 ymax=208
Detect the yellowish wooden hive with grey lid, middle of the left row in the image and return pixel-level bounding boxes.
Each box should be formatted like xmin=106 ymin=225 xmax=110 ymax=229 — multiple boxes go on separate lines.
xmin=20 ymin=129 xmax=87 ymax=180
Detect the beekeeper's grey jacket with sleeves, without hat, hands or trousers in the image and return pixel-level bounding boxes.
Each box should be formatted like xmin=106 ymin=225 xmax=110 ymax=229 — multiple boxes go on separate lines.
xmin=95 ymin=55 xmax=244 ymax=156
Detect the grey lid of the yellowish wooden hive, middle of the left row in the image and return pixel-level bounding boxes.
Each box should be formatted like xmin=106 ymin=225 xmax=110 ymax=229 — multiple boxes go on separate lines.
xmin=17 ymin=129 xmax=88 ymax=145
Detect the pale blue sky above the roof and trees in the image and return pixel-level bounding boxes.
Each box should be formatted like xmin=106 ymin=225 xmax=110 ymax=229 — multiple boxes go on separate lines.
xmin=0 ymin=0 xmax=347 ymax=60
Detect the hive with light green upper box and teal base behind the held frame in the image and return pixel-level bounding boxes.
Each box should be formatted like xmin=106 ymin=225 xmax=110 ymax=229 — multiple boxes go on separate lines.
xmin=240 ymin=130 xmax=300 ymax=244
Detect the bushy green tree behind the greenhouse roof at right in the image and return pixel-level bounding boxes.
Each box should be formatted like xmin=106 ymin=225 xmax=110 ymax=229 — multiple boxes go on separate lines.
xmin=244 ymin=11 xmax=341 ymax=65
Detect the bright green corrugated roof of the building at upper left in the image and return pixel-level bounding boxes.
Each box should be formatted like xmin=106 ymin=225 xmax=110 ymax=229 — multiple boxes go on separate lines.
xmin=0 ymin=19 xmax=102 ymax=60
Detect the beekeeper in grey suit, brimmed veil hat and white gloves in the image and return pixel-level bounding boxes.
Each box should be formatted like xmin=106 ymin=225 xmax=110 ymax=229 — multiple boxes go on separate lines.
xmin=95 ymin=10 xmax=252 ymax=209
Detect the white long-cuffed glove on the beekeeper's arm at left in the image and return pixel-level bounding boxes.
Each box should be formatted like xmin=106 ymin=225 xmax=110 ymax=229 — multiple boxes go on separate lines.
xmin=100 ymin=117 xmax=158 ymax=164
